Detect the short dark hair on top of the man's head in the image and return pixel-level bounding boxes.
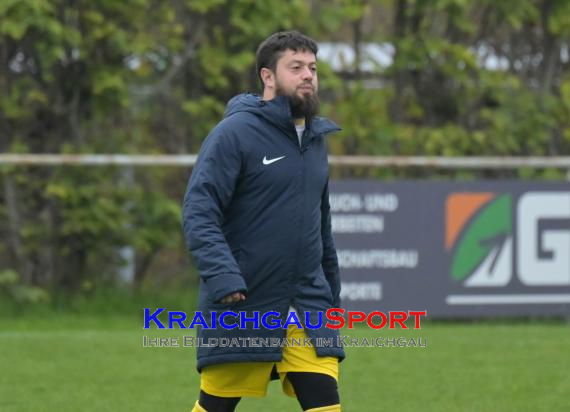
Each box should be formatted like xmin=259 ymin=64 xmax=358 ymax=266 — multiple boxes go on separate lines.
xmin=255 ymin=30 xmax=319 ymax=88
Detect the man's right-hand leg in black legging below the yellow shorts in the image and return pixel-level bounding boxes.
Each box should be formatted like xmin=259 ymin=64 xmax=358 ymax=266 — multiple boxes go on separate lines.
xmin=287 ymin=372 xmax=340 ymax=412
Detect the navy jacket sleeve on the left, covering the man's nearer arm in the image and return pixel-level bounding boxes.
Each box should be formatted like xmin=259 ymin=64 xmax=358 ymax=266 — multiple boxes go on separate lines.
xmin=182 ymin=126 xmax=247 ymax=302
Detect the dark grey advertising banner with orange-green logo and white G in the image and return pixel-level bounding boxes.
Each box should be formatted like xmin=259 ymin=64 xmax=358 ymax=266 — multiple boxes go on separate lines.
xmin=330 ymin=180 xmax=570 ymax=318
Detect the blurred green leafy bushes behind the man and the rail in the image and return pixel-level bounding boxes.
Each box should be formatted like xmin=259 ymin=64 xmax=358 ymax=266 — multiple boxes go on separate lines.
xmin=0 ymin=0 xmax=570 ymax=311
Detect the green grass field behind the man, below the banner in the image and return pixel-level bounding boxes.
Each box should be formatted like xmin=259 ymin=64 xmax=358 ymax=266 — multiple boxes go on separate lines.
xmin=0 ymin=315 xmax=570 ymax=412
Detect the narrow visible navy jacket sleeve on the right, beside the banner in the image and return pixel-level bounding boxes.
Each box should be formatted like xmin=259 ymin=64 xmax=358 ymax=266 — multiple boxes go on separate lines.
xmin=321 ymin=181 xmax=341 ymax=308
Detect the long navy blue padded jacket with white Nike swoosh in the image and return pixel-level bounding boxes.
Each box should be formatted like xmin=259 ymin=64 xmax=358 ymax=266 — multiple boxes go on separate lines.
xmin=183 ymin=94 xmax=344 ymax=370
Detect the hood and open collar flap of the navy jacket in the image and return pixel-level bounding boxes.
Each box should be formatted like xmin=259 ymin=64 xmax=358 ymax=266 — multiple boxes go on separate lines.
xmin=224 ymin=93 xmax=341 ymax=135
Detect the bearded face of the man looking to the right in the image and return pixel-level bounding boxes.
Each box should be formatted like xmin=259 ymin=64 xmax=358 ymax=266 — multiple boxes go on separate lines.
xmin=275 ymin=50 xmax=319 ymax=118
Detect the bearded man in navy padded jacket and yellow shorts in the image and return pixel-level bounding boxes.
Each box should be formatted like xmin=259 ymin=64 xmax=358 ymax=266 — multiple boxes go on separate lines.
xmin=183 ymin=32 xmax=344 ymax=412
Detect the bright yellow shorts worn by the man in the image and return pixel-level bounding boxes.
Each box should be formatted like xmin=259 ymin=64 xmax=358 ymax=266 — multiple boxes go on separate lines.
xmin=200 ymin=325 xmax=338 ymax=398
